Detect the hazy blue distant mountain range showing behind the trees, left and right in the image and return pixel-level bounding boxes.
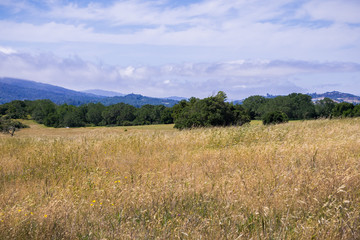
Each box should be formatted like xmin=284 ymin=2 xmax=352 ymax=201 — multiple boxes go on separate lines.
xmin=0 ymin=78 xmax=360 ymax=107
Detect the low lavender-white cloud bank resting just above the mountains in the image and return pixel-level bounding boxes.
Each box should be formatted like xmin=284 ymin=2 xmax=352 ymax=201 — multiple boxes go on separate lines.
xmin=0 ymin=53 xmax=360 ymax=99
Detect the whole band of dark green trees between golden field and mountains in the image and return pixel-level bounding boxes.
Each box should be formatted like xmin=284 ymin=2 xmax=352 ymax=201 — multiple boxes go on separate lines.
xmin=0 ymin=92 xmax=360 ymax=129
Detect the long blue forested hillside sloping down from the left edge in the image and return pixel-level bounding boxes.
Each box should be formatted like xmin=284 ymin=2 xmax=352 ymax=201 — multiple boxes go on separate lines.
xmin=0 ymin=78 xmax=178 ymax=107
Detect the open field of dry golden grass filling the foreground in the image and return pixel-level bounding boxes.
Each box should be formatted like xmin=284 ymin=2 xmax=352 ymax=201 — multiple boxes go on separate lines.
xmin=0 ymin=118 xmax=360 ymax=239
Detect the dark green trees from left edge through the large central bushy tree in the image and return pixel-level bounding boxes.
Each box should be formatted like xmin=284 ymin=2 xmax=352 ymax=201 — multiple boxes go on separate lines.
xmin=0 ymin=92 xmax=250 ymax=129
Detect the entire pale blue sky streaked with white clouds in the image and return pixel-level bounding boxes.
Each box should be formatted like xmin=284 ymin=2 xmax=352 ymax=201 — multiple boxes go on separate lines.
xmin=0 ymin=0 xmax=360 ymax=99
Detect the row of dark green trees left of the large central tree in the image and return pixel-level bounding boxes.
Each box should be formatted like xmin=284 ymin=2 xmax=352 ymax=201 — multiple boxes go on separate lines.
xmin=0 ymin=100 xmax=173 ymax=128
